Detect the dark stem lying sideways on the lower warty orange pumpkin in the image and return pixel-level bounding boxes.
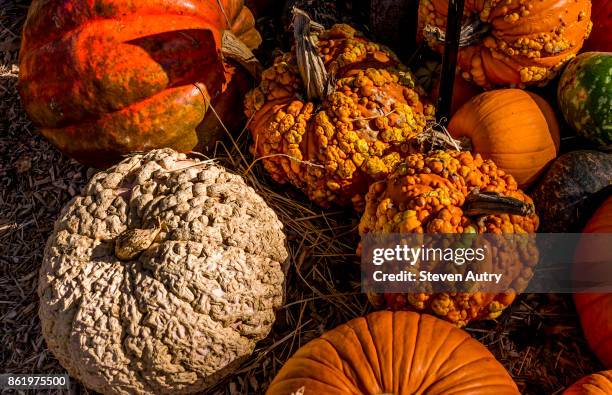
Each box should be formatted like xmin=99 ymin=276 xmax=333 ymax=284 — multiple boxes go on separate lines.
xmin=463 ymin=188 xmax=535 ymax=216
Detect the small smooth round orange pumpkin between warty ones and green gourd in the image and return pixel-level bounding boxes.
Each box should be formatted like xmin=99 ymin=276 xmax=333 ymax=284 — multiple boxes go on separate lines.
xmin=448 ymin=89 xmax=560 ymax=187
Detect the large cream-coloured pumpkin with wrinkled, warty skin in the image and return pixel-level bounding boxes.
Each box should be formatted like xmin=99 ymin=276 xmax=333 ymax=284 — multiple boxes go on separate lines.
xmin=38 ymin=149 xmax=288 ymax=394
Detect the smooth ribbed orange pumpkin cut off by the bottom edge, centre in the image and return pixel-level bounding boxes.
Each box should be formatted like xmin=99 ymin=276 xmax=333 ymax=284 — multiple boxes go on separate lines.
xmin=267 ymin=311 xmax=519 ymax=395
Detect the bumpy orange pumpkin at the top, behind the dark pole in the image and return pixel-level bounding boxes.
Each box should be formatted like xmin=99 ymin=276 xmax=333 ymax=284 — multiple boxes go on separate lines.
xmin=419 ymin=0 xmax=591 ymax=88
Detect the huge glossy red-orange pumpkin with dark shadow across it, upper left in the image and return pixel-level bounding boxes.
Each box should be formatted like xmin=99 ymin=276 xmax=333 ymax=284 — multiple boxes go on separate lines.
xmin=19 ymin=0 xmax=261 ymax=167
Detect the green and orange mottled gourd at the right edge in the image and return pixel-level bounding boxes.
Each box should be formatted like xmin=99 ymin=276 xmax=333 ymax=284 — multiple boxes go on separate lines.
xmin=557 ymin=52 xmax=612 ymax=148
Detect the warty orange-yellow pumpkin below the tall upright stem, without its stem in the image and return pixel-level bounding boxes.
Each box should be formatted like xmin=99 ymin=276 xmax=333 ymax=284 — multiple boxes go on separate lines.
xmin=246 ymin=25 xmax=433 ymax=206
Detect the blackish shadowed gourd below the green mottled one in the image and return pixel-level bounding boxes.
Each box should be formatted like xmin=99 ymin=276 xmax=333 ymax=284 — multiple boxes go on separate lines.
xmin=533 ymin=150 xmax=612 ymax=233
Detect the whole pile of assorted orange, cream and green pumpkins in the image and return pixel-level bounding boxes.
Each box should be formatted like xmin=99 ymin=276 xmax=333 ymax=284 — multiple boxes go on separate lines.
xmin=13 ymin=0 xmax=612 ymax=395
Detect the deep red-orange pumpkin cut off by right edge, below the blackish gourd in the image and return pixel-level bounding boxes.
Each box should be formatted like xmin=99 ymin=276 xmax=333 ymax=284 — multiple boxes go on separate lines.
xmin=574 ymin=197 xmax=612 ymax=369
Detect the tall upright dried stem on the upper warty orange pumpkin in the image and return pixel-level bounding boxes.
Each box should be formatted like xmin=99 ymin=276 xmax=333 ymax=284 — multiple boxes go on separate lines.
xmin=292 ymin=7 xmax=331 ymax=100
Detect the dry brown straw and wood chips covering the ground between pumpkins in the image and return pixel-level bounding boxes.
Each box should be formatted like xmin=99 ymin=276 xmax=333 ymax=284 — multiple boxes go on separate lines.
xmin=0 ymin=0 xmax=601 ymax=394
